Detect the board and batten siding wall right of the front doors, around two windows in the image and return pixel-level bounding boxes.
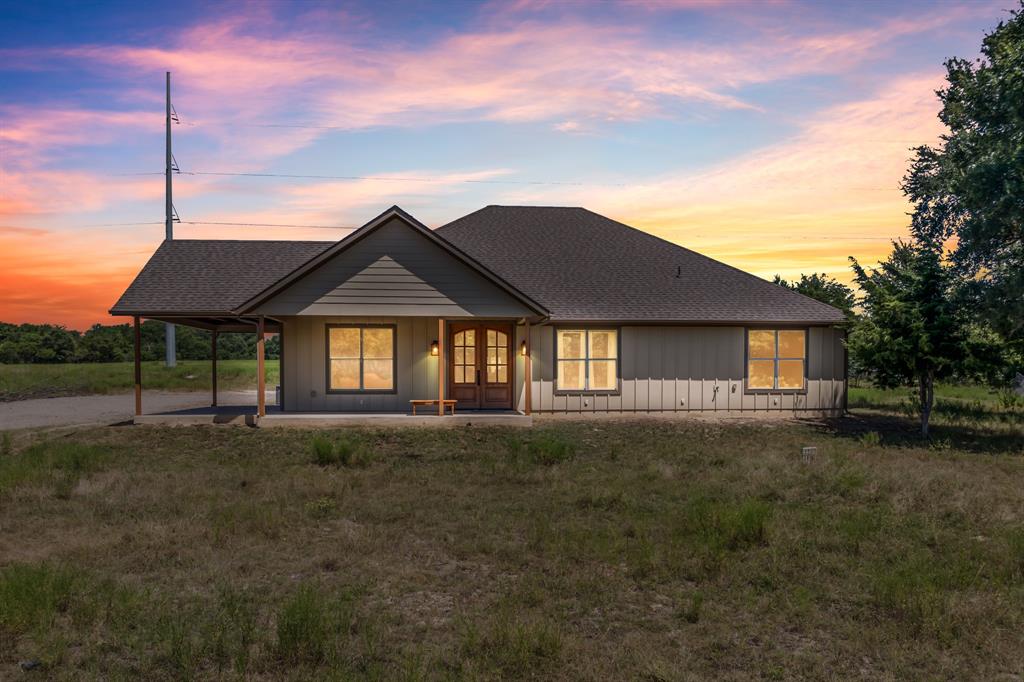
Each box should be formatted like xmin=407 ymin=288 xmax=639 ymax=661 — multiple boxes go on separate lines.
xmin=516 ymin=325 xmax=846 ymax=414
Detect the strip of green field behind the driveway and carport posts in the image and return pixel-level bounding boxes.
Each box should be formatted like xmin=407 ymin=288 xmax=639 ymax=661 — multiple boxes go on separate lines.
xmin=0 ymin=359 xmax=279 ymax=401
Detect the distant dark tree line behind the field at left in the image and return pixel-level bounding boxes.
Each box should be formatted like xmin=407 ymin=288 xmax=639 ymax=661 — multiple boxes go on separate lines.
xmin=0 ymin=319 xmax=281 ymax=365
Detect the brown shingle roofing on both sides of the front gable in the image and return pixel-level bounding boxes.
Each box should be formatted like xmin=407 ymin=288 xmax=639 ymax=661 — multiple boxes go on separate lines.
xmin=111 ymin=206 xmax=843 ymax=324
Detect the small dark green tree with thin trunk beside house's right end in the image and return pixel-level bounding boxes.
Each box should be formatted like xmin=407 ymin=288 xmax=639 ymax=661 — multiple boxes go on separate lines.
xmin=848 ymin=242 xmax=972 ymax=437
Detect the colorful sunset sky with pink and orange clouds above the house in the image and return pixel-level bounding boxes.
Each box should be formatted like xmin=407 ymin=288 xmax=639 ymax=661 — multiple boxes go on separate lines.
xmin=0 ymin=0 xmax=1014 ymax=329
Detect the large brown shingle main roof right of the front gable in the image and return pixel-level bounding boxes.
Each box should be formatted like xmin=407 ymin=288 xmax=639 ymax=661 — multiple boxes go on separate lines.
xmin=437 ymin=206 xmax=843 ymax=324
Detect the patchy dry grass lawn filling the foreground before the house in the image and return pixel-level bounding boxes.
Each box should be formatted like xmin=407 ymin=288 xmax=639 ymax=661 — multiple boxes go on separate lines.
xmin=0 ymin=405 xmax=1024 ymax=680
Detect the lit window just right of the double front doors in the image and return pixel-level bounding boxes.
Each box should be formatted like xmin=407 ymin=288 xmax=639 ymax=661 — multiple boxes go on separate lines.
xmin=555 ymin=329 xmax=618 ymax=391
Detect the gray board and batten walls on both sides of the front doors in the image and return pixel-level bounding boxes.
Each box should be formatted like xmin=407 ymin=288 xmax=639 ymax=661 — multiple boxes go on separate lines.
xmin=283 ymin=316 xmax=846 ymax=414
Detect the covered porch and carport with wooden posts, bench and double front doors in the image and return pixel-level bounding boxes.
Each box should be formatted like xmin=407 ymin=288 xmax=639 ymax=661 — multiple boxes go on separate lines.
xmin=133 ymin=315 xmax=532 ymax=427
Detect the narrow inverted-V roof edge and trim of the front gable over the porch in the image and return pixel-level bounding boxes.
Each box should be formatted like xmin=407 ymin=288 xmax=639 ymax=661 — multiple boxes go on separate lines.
xmin=238 ymin=206 xmax=547 ymax=315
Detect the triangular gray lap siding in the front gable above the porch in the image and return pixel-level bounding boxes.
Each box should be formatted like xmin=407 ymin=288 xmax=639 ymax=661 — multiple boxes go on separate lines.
xmin=253 ymin=218 xmax=532 ymax=317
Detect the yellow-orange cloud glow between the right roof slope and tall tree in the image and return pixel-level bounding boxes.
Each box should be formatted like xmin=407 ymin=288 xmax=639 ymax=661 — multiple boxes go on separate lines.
xmin=495 ymin=74 xmax=941 ymax=281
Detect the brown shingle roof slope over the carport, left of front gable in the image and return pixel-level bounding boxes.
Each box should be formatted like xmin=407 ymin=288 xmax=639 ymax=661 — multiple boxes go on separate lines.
xmin=111 ymin=240 xmax=336 ymax=314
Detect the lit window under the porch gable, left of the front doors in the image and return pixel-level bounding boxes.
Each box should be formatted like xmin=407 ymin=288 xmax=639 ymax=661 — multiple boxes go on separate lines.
xmin=327 ymin=325 xmax=395 ymax=392
